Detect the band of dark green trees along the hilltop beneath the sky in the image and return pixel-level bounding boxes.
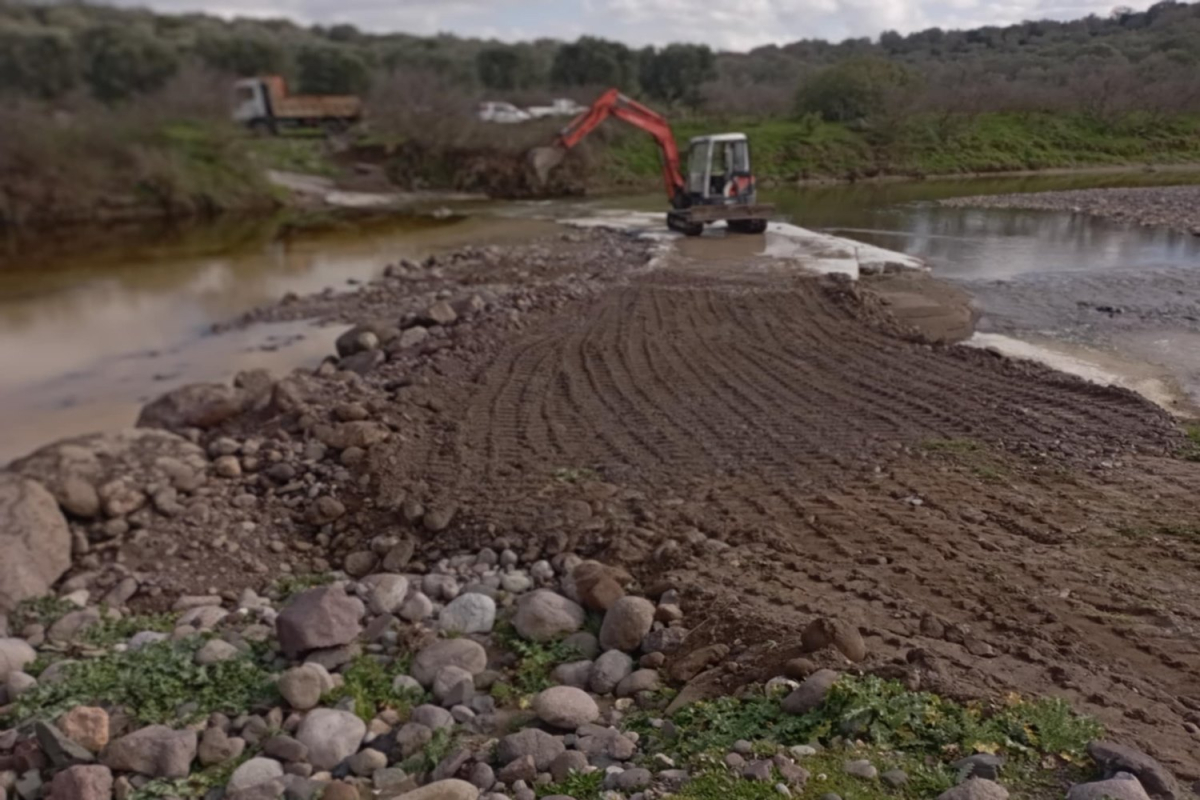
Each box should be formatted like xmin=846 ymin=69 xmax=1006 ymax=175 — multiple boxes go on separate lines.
xmin=0 ymin=0 xmax=1200 ymax=124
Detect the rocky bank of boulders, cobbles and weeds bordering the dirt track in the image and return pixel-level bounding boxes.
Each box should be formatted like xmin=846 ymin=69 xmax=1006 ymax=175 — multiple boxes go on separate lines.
xmin=0 ymin=226 xmax=1182 ymax=800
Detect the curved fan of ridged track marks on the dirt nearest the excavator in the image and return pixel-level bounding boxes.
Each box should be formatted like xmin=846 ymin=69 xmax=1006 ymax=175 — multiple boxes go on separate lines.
xmin=431 ymin=268 xmax=1165 ymax=520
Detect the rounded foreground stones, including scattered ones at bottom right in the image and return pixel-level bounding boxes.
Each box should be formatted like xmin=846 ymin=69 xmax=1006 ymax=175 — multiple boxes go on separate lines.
xmin=0 ymin=534 xmax=1176 ymax=800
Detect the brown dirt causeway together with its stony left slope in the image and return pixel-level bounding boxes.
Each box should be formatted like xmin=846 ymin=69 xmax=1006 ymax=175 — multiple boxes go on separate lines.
xmin=2 ymin=226 xmax=1200 ymax=778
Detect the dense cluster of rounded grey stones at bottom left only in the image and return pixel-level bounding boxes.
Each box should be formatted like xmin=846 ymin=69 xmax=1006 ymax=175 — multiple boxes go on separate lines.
xmin=0 ymin=551 xmax=686 ymax=800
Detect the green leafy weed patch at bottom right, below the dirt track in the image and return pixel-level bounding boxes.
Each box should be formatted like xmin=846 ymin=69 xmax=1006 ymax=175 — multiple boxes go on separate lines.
xmin=629 ymin=676 xmax=1103 ymax=800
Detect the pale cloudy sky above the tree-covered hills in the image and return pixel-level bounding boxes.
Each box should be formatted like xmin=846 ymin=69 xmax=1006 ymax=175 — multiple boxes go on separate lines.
xmin=116 ymin=0 xmax=1150 ymax=49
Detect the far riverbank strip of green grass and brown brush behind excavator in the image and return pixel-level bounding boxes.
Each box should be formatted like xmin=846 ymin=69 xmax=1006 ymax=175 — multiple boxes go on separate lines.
xmin=14 ymin=107 xmax=1200 ymax=229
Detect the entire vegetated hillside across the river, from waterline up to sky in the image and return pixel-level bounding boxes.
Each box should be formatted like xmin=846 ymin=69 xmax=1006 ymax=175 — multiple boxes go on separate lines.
xmin=0 ymin=0 xmax=1200 ymax=224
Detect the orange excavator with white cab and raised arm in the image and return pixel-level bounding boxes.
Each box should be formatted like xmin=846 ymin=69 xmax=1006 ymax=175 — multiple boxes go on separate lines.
xmin=529 ymin=89 xmax=774 ymax=236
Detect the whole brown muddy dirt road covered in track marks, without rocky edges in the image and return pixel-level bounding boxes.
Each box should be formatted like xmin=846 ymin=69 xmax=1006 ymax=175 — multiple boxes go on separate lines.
xmin=348 ymin=242 xmax=1200 ymax=777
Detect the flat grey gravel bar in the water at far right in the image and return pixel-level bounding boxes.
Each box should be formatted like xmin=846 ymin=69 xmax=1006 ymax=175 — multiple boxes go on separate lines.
xmin=940 ymin=186 xmax=1200 ymax=234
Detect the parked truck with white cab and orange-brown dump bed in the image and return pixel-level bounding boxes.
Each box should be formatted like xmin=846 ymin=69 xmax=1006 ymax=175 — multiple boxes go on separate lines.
xmin=233 ymin=76 xmax=362 ymax=133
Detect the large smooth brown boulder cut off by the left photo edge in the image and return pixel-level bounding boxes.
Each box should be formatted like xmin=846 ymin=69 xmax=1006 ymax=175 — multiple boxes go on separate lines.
xmin=0 ymin=471 xmax=71 ymax=613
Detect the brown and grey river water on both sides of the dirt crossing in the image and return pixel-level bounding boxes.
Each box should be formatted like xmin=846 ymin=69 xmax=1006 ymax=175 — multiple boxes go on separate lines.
xmin=0 ymin=173 xmax=1200 ymax=463
